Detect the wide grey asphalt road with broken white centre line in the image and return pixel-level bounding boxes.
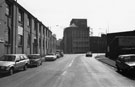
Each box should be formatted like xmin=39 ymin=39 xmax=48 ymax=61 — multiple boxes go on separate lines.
xmin=0 ymin=54 xmax=135 ymax=87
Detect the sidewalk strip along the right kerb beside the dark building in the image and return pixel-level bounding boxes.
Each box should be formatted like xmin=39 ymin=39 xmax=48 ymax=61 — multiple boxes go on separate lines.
xmin=95 ymin=55 xmax=116 ymax=68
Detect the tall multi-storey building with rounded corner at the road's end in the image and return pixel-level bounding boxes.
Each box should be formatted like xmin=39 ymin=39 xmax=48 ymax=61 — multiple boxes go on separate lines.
xmin=63 ymin=19 xmax=89 ymax=53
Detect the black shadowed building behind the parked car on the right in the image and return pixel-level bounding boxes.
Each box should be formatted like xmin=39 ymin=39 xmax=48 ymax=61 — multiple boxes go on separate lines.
xmin=106 ymin=31 xmax=135 ymax=59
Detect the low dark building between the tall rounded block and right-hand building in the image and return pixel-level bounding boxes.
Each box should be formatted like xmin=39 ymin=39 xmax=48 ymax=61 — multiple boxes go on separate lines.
xmin=89 ymin=34 xmax=107 ymax=53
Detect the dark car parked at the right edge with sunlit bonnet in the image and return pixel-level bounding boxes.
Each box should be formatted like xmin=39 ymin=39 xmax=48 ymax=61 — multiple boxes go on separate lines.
xmin=116 ymin=54 xmax=135 ymax=71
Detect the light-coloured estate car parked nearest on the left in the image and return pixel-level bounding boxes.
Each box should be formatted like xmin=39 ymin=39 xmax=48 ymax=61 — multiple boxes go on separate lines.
xmin=0 ymin=54 xmax=29 ymax=75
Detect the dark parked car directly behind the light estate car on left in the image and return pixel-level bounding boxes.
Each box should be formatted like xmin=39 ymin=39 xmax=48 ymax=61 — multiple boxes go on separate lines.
xmin=28 ymin=54 xmax=44 ymax=66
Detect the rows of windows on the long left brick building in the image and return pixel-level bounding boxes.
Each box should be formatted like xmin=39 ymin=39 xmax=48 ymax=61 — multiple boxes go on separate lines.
xmin=5 ymin=3 xmax=51 ymax=48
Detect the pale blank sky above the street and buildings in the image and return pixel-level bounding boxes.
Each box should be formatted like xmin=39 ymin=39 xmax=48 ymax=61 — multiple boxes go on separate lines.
xmin=17 ymin=0 xmax=135 ymax=39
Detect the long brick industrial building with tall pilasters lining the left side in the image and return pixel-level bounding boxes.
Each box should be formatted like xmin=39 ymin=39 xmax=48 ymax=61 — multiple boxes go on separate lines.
xmin=0 ymin=0 xmax=56 ymax=56
